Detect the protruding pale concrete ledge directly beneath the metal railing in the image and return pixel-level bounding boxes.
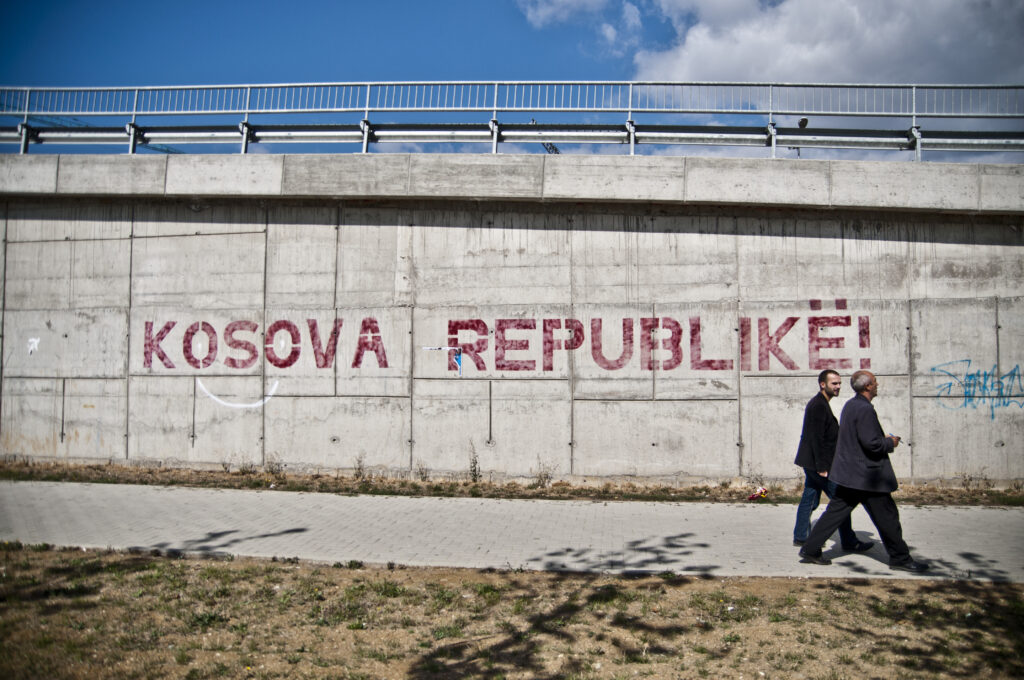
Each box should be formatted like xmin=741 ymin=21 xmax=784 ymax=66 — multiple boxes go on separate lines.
xmin=0 ymin=154 xmax=1024 ymax=214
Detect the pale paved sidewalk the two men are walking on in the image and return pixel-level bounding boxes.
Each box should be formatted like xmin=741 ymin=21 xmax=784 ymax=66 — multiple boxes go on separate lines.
xmin=0 ymin=481 xmax=1024 ymax=583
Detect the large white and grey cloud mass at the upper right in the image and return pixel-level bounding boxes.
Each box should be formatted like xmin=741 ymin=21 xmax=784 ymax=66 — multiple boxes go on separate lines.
xmin=635 ymin=0 xmax=1024 ymax=83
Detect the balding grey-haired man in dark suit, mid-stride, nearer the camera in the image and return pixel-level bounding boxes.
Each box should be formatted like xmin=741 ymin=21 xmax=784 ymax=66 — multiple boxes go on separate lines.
xmin=800 ymin=371 xmax=928 ymax=573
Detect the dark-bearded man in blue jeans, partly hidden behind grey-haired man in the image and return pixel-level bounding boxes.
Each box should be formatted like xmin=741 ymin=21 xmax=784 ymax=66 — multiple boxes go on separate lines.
xmin=793 ymin=369 xmax=874 ymax=552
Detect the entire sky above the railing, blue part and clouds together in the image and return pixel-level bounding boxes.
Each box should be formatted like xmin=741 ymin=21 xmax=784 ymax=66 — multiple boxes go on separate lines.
xmin=0 ymin=0 xmax=1024 ymax=159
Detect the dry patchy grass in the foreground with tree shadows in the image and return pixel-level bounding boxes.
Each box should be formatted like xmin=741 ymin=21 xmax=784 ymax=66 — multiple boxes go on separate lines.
xmin=0 ymin=544 xmax=1024 ymax=679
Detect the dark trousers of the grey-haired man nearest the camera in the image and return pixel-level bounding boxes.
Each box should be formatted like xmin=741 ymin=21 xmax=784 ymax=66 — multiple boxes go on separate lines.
xmin=801 ymin=486 xmax=910 ymax=564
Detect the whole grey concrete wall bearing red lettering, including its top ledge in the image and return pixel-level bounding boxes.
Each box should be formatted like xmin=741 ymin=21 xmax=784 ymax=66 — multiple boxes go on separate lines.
xmin=0 ymin=155 xmax=1024 ymax=481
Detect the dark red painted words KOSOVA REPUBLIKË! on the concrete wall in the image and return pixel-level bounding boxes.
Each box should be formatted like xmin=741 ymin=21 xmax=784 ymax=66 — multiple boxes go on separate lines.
xmin=142 ymin=315 xmax=870 ymax=372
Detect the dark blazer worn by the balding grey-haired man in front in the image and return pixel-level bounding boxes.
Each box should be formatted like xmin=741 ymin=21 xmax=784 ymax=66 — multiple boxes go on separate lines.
xmin=828 ymin=394 xmax=899 ymax=494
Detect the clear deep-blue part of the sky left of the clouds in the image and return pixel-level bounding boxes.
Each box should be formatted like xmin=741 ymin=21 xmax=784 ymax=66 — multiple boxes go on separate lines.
xmin=0 ymin=0 xmax=647 ymax=86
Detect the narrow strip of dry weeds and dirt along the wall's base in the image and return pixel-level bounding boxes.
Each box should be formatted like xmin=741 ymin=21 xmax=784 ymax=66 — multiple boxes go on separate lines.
xmin=0 ymin=460 xmax=1024 ymax=506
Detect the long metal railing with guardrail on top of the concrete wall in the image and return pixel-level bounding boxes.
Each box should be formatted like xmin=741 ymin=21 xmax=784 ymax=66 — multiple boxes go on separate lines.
xmin=0 ymin=81 xmax=1024 ymax=157
